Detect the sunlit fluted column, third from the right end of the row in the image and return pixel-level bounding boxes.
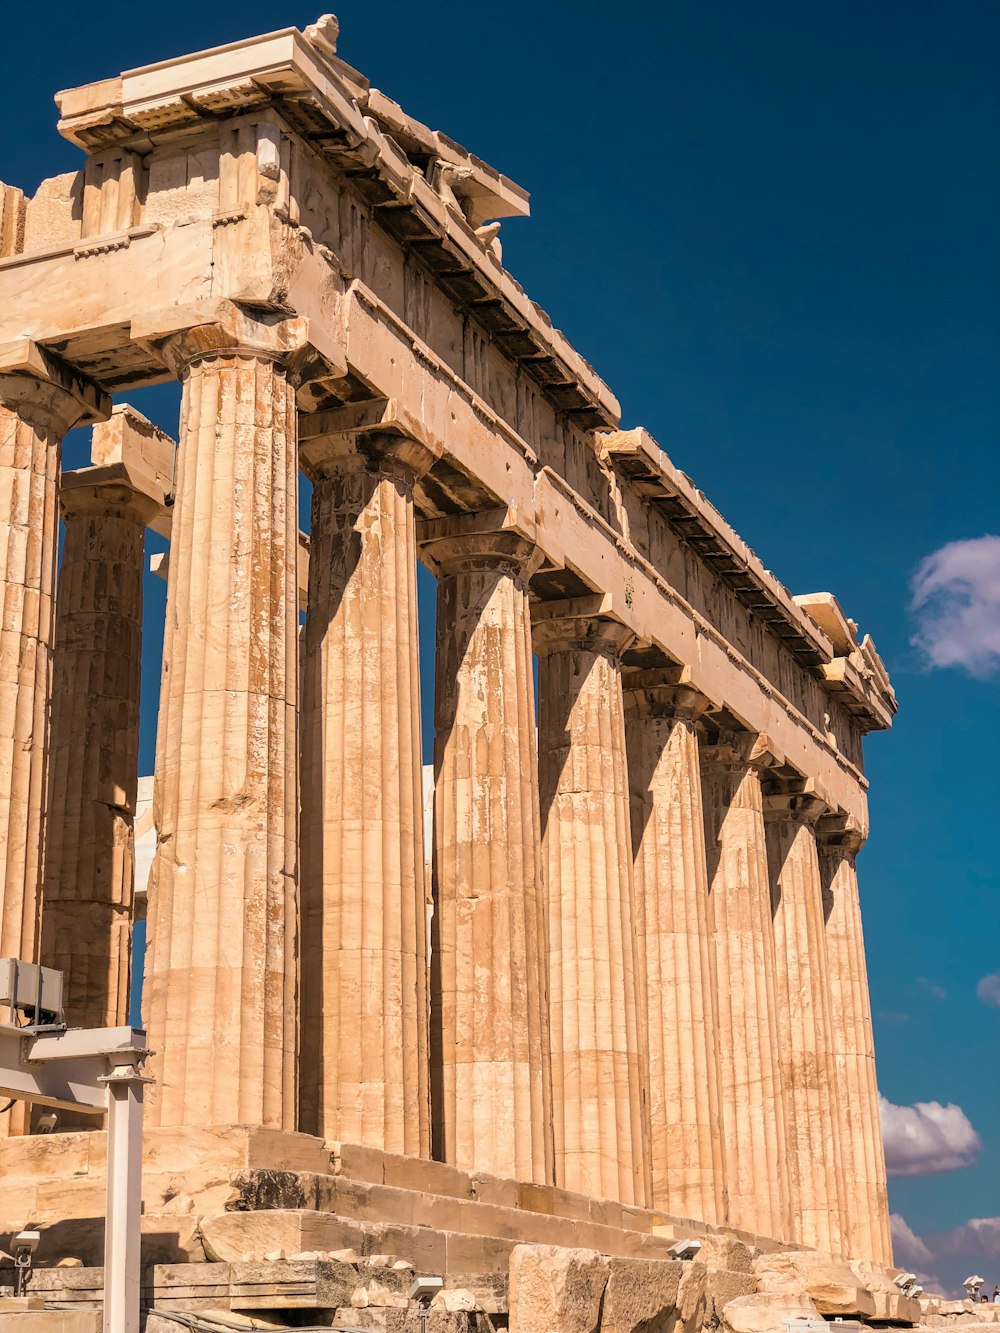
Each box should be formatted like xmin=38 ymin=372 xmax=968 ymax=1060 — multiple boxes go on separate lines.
xmin=701 ymin=732 xmax=791 ymax=1240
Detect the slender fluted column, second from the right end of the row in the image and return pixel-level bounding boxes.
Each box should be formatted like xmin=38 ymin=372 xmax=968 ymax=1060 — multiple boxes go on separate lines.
xmin=765 ymin=782 xmax=844 ymax=1254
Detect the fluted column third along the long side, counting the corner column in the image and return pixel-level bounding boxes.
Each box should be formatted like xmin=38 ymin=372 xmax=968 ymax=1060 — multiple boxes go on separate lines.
xmin=424 ymin=516 xmax=552 ymax=1184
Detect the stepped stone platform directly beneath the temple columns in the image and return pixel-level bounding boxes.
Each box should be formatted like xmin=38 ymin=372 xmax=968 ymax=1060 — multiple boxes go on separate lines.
xmin=0 ymin=1126 xmax=776 ymax=1272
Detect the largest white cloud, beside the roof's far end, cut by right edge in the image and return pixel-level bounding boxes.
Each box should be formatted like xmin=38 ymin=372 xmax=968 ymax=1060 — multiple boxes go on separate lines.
xmin=909 ymin=536 xmax=1000 ymax=677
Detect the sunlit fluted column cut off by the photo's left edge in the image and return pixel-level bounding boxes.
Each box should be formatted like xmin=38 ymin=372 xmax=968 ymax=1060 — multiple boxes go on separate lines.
xmin=0 ymin=357 xmax=108 ymax=981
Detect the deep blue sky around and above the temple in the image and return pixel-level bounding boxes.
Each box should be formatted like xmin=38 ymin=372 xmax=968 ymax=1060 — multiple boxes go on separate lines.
xmin=0 ymin=0 xmax=1000 ymax=1284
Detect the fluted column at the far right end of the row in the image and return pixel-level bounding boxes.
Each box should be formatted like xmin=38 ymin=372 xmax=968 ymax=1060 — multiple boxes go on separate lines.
xmin=820 ymin=817 xmax=892 ymax=1265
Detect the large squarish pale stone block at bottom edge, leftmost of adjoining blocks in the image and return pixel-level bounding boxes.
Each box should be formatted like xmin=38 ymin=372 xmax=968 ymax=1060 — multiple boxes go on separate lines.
xmin=509 ymin=1245 xmax=609 ymax=1333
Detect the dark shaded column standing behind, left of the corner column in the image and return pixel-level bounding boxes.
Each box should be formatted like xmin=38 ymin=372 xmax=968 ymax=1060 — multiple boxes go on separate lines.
xmin=41 ymin=468 xmax=159 ymax=1028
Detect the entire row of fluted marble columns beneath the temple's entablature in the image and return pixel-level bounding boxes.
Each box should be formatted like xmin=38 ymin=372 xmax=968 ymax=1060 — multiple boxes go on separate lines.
xmin=0 ymin=329 xmax=889 ymax=1258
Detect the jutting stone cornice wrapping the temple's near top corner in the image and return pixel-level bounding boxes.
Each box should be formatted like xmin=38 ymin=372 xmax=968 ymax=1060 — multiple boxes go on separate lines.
xmin=59 ymin=28 xmax=621 ymax=427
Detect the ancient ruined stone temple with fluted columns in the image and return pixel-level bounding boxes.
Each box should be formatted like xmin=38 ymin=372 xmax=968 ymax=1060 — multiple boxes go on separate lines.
xmin=0 ymin=17 xmax=919 ymax=1333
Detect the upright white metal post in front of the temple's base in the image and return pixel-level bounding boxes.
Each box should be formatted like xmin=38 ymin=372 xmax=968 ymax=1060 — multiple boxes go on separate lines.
xmin=104 ymin=1060 xmax=148 ymax=1333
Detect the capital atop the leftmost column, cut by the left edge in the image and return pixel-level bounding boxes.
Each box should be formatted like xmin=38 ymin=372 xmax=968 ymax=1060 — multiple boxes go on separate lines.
xmin=0 ymin=337 xmax=111 ymax=435
